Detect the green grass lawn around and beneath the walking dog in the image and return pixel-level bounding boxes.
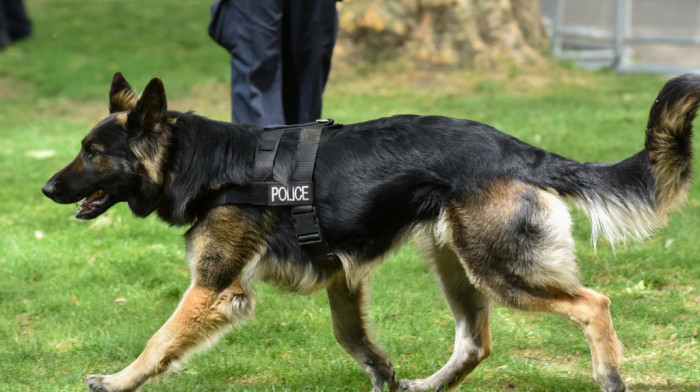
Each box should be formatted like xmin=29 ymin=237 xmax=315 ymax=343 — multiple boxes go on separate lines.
xmin=0 ymin=0 xmax=700 ymax=391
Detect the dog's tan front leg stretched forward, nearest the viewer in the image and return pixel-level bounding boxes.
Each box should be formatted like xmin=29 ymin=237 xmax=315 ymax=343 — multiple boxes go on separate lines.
xmin=87 ymin=209 xmax=260 ymax=392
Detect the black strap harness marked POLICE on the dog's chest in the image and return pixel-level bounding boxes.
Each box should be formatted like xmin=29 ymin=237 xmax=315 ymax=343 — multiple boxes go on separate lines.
xmin=200 ymin=119 xmax=339 ymax=261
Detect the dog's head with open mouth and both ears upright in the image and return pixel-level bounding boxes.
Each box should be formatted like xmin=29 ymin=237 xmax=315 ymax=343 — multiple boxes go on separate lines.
xmin=42 ymin=72 xmax=168 ymax=219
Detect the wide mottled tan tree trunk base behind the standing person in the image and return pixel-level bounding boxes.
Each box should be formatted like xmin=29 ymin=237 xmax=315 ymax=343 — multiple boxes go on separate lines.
xmin=337 ymin=0 xmax=548 ymax=70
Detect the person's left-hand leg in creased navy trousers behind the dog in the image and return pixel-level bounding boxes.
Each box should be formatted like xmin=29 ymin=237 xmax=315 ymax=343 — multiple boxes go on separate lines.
xmin=229 ymin=0 xmax=285 ymax=126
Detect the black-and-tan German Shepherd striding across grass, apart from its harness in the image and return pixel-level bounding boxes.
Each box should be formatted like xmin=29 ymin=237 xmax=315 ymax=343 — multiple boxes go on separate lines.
xmin=42 ymin=73 xmax=700 ymax=392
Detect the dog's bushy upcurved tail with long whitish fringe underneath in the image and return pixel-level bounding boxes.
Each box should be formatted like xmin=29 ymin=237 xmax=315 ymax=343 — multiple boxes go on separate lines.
xmin=563 ymin=74 xmax=700 ymax=244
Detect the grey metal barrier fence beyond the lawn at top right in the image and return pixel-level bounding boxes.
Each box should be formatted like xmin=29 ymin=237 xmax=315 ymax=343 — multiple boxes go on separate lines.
xmin=540 ymin=0 xmax=700 ymax=74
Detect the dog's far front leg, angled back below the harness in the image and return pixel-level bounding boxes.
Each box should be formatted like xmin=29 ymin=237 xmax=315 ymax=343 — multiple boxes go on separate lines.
xmin=326 ymin=275 xmax=397 ymax=392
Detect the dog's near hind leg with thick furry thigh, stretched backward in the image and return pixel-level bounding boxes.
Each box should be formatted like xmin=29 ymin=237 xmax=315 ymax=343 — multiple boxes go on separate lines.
xmin=446 ymin=182 xmax=625 ymax=392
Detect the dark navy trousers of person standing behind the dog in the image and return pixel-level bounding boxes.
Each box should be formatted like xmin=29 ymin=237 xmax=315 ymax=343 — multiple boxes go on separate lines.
xmin=210 ymin=0 xmax=338 ymax=126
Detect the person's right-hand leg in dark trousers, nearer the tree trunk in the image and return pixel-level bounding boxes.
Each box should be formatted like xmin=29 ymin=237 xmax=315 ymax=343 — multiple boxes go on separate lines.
xmin=282 ymin=0 xmax=338 ymax=124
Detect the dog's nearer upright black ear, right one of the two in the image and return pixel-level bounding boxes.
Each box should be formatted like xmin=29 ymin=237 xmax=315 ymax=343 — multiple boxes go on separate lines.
xmin=127 ymin=78 xmax=168 ymax=136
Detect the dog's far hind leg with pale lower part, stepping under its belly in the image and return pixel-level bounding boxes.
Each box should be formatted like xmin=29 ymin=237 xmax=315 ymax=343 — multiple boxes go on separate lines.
xmin=399 ymin=241 xmax=491 ymax=391
